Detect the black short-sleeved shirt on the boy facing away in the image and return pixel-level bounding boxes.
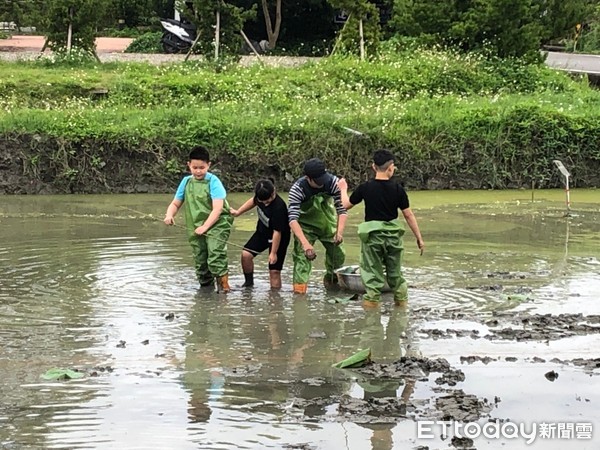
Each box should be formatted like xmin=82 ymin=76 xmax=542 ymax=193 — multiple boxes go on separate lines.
xmin=350 ymin=179 xmax=410 ymax=222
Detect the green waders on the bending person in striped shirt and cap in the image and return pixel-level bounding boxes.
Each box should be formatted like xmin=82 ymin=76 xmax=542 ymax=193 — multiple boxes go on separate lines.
xmin=293 ymin=194 xmax=346 ymax=286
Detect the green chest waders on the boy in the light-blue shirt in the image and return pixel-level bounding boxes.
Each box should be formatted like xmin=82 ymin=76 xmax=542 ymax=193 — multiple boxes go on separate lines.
xmin=183 ymin=178 xmax=233 ymax=285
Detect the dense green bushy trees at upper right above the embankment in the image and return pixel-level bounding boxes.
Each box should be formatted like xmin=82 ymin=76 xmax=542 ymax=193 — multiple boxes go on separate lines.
xmin=392 ymin=0 xmax=592 ymax=59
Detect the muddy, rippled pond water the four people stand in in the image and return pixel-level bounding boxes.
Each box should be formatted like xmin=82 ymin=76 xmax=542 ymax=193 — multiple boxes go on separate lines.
xmin=0 ymin=190 xmax=600 ymax=450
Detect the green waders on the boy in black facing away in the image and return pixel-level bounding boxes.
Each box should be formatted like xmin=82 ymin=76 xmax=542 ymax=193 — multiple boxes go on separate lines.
xmin=358 ymin=219 xmax=408 ymax=302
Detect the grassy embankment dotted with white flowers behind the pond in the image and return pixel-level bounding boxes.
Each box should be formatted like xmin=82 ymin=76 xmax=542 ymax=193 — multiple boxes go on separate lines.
xmin=0 ymin=51 xmax=600 ymax=192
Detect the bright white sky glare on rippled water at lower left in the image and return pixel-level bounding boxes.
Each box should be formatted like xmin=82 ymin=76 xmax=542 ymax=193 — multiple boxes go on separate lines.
xmin=39 ymin=236 xmax=198 ymax=448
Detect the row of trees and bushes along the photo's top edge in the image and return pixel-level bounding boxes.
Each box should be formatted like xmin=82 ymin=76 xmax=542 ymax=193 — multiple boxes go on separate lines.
xmin=0 ymin=0 xmax=600 ymax=58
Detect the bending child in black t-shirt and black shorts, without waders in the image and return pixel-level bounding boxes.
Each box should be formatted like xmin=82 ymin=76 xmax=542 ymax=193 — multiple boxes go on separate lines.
xmin=230 ymin=180 xmax=290 ymax=289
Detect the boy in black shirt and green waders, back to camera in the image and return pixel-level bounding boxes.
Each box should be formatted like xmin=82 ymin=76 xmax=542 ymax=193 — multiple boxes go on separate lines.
xmin=338 ymin=150 xmax=425 ymax=307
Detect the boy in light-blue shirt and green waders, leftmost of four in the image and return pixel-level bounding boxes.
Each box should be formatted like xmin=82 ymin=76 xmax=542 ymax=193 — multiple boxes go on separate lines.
xmin=164 ymin=146 xmax=233 ymax=292
